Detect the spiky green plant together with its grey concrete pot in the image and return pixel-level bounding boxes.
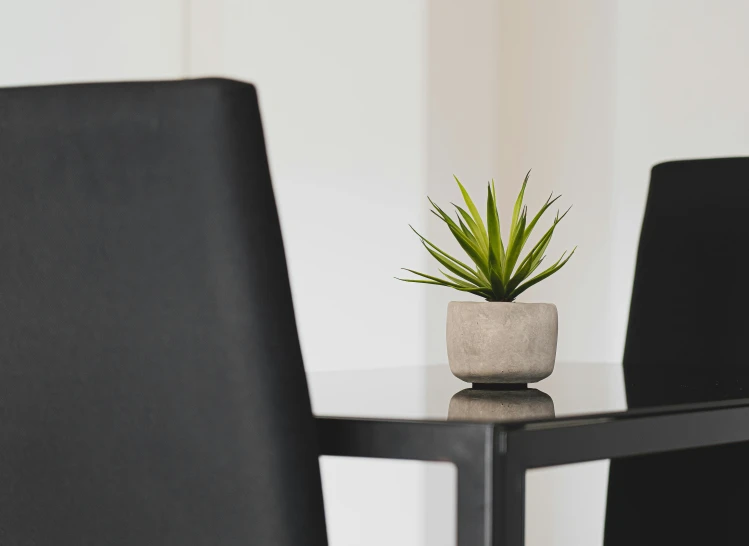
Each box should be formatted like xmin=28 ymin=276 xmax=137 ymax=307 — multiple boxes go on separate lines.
xmin=399 ymin=171 xmax=575 ymax=386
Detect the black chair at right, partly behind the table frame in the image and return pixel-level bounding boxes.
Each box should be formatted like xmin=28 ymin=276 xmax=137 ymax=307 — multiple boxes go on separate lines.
xmin=604 ymin=158 xmax=749 ymax=546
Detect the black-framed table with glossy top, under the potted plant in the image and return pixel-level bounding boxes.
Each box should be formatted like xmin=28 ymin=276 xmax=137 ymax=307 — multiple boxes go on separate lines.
xmin=309 ymin=363 xmax=749 ymax=546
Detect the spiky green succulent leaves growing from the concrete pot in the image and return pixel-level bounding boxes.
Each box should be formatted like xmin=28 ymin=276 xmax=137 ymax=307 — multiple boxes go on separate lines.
xmin=398 ymin=171 xmax=577 ymax=302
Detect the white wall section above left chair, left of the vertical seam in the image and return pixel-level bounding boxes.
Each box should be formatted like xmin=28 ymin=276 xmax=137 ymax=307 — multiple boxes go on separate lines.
xmin=0 ymin=0 xmax=184 ymax=86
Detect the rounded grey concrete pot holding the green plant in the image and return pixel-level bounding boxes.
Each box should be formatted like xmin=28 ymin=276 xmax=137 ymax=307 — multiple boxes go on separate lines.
xmin=447 ymin=301 xmax=558 ymax=383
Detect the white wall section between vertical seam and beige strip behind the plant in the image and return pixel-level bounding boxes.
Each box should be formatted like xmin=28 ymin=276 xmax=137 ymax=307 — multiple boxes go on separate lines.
xmin=186 ymin=0 xmax=426 ymax=370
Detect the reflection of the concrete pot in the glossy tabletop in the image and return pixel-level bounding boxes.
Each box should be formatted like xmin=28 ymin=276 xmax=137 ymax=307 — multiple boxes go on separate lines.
xmin=447 ymin=389 xmax=554 ymax=422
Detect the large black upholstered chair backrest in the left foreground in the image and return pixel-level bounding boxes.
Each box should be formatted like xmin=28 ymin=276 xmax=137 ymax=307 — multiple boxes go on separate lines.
xmin=0 ymin=79 xmax=326 ymax=546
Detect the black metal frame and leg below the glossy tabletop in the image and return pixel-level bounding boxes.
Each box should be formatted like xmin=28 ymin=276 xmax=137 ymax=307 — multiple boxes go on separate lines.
xmin=317 ymin=400 xmax=749 ymax=546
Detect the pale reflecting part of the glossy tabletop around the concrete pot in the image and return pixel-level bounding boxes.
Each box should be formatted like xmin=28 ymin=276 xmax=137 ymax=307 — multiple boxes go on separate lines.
xmin=308 ymin=363 xmax=627 ymax=422
